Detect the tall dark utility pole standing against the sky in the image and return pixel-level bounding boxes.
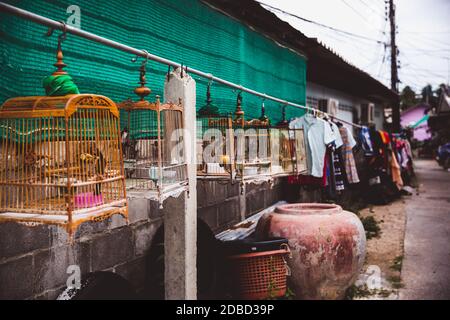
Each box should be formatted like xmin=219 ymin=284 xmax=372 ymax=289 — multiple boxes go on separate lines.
xmin=389 ymin=0 xmax=400 ymax=132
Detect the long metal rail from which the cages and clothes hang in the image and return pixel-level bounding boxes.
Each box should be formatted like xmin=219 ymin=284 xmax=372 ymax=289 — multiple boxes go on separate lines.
xmin=0 ymin=2 xmax=362 ymax=128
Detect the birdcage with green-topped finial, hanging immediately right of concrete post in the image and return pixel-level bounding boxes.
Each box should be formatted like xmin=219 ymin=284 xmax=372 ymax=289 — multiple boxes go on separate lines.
xmin=197 ymin=83 xmax=235 ymax=178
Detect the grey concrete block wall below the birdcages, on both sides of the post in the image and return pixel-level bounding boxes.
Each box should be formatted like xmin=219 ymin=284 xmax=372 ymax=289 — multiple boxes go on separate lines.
xmin=0 ymin=179 xmax=283 ymax=299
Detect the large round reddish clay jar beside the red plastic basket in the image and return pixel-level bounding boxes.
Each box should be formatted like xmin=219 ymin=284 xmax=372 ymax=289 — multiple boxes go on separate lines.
xmin=256 ymin=203 xmax=366 ymax=299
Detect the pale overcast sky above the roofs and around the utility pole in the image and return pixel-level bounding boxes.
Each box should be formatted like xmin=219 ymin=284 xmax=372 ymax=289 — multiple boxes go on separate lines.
xmin=258 ymin=0 xmax=450 ymax=93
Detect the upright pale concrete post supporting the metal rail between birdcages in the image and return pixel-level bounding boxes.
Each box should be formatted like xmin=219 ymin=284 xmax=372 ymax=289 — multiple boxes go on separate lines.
xmin=164 ymin=68 xmax=197 ymax=300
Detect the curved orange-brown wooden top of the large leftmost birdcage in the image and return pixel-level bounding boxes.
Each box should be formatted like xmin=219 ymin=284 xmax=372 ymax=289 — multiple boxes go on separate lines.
xmin=0 ymin=94 xmax=119 ymax=117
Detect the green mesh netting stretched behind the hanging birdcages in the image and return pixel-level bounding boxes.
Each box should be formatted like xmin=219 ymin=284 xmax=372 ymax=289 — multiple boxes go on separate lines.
xmin=0 ymin=0 xmax=306 ymax=123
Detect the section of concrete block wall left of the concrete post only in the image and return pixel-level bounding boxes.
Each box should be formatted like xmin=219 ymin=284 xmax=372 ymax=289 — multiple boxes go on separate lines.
xmin=0 ymin=195 xmax=168 ymax=299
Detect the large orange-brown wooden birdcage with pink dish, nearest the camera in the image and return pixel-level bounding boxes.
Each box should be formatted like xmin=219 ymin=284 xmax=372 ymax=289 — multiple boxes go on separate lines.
xmin=0 ymin=94 xmax=128 ymax=233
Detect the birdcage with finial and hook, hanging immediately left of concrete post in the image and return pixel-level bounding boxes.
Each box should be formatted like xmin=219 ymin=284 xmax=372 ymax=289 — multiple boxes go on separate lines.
xmin=118 ymin=61 xmax=187 ymax=203
